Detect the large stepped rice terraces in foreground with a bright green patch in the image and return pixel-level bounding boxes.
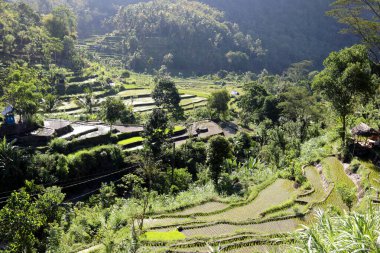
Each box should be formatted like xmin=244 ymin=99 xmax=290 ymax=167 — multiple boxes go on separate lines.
xmin=78 ymin=162 xmax=360 ymax=253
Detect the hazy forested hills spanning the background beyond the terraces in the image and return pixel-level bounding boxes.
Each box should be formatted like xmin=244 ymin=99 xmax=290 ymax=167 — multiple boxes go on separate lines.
xmin=5 ymin=0 xmax=356 ymax=74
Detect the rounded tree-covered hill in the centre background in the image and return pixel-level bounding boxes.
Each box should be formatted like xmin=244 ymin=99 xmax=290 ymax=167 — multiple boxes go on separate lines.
xmin=108 ymin=0 xmax=262 ymax=73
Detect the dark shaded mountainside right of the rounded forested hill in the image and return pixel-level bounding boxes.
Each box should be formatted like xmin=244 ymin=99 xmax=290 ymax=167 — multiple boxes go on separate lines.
xmin=201 ymin=0 xmax=356 ymax=72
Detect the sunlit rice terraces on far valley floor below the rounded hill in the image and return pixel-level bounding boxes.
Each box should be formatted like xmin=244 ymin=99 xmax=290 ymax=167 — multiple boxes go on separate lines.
xmin=47 ymin=69 xmax=241 ymax=120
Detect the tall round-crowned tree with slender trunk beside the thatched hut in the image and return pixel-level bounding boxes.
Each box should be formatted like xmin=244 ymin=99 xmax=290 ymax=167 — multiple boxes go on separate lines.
xmin=313 ymin=45 xmax=378 ymax=145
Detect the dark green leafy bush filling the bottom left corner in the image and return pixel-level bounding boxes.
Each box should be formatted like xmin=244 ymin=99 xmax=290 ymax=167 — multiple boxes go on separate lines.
xmin=0 ymin=187 xmax=64 ymax=252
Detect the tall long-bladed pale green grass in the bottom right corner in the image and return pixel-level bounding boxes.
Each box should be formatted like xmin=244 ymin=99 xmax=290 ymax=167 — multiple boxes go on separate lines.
xmin=292 ymin=208 xmax=380 ymax=253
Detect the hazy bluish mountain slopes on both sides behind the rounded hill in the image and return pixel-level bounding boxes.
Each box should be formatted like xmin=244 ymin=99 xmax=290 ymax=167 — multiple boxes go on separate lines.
xmin=14 ymin=0 xmax=356 ymax=73
